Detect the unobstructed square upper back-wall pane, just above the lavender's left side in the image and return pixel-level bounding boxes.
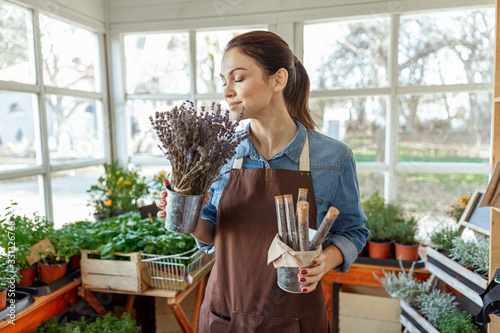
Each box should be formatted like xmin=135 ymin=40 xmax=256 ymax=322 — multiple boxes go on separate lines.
xmin=124 ymin=33 xmax=190 ymax=94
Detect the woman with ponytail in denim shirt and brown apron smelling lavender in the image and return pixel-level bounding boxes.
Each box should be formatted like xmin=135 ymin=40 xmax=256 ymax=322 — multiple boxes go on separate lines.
xmin=158 ymin=31 xmax=368 ymax=333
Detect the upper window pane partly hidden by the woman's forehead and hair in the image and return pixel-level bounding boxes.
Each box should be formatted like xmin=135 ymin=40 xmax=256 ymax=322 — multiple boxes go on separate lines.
xmin=196 ymin=30 xmax=258 ymax=93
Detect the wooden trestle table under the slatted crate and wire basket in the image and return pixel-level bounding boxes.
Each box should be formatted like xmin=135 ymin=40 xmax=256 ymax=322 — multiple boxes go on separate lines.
xmin=78 ymin=272 xmax=208 ymax=333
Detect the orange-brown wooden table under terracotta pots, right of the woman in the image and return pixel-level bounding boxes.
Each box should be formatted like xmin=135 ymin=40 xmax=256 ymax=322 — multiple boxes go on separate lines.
xmin=321 ymin=263 xmax=431 ymax=333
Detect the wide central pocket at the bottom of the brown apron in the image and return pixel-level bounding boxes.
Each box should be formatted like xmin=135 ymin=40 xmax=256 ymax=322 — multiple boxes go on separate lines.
xmin=227 ymin=312 xmax=300 ymax=333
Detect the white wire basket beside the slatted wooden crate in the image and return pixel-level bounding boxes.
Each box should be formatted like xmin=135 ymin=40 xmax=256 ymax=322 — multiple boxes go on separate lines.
xmin=141 ymin=248 xmax=215 ymax=291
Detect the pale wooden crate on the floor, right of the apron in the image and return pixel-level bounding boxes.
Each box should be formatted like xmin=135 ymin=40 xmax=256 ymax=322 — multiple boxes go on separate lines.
xmin=339 ymin=285 xmax=401 ymax=333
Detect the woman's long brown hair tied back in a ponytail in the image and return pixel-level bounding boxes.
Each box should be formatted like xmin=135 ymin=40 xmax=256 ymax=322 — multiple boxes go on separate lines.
xmin=226 ymin=31 xmax=316 ymax=129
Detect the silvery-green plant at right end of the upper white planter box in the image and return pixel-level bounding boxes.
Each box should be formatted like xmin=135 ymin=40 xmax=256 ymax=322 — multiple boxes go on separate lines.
xmin=450 ymin=237 xmax=489 ymax=274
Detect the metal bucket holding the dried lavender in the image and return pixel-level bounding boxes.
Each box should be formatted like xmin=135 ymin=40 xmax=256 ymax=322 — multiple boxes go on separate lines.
xmin=165 ymin=186 xmax=205 ymax=234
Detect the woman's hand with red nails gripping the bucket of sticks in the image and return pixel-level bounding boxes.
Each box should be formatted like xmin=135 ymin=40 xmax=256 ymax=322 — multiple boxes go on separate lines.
xmin=298 ymin=245 xmax=344 ymax=293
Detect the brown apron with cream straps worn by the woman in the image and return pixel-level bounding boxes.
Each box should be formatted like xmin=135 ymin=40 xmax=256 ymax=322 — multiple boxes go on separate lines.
xmin=199 ymin=137 xmax=329 ymax=333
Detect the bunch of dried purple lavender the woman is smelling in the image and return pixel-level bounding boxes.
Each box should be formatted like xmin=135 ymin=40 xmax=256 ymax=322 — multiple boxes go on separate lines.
xmin=149 ymin=101 xmax=249 ymax=195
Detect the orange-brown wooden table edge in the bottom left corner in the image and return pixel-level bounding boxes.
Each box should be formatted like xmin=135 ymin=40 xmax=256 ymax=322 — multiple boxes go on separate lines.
xmin=0 ymin=279 xmax=81 ymax=333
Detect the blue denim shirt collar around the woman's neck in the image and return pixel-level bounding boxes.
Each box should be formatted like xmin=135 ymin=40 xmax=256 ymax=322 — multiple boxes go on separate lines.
xmin=236 ymin=119 xmax=307 ymax=164
